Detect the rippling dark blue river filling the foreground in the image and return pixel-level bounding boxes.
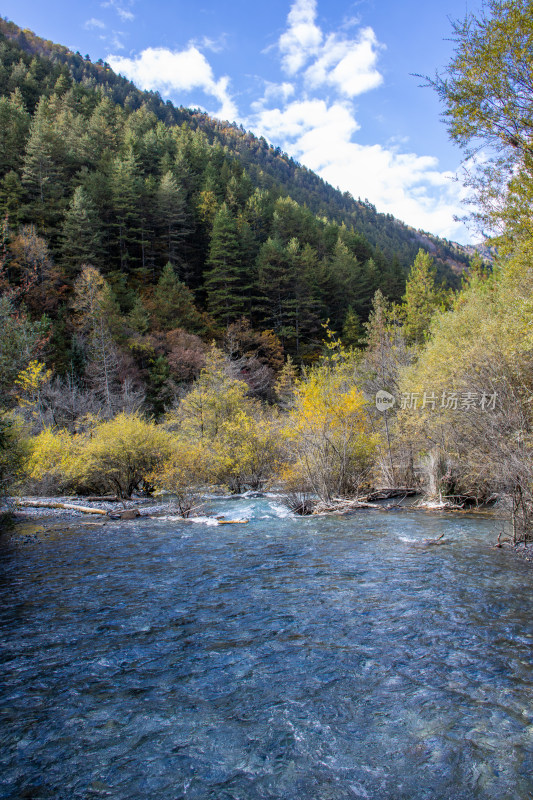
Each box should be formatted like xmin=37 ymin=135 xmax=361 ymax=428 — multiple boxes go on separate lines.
xmin=0 ymin=498 xmax=533 ymax=800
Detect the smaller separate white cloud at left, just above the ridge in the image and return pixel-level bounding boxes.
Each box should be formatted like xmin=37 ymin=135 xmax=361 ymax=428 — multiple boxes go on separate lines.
xmin=107 ymin=45 xmax=237 ymax=121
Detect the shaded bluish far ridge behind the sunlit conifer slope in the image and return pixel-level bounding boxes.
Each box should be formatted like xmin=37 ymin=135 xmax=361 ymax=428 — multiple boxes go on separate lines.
xmin=0 ymin=19 xmax=478 ymax=286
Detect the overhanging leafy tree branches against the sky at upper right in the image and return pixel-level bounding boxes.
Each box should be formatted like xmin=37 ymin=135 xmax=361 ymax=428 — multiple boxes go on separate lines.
xmin=429 ymin=0 xmax=533 ymax=247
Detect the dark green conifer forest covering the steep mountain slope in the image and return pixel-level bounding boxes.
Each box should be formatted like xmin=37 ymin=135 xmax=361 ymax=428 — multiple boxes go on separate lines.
xmin=0 ymin=16 xmax=412 ymax=373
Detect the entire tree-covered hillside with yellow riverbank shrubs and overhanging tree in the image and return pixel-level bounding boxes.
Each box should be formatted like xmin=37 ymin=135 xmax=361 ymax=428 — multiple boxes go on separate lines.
xmin=7 ymin=0 xmax=533 ymax=541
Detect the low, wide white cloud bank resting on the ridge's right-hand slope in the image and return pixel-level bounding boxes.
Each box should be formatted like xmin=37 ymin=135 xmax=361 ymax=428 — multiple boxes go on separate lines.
xmin=252 ymin=98 xmax=465 ymax=238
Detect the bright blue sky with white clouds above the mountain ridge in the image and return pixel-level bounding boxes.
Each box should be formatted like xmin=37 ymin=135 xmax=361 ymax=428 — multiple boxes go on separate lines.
xmin=2 ymin=0 xmax=481 ymax=242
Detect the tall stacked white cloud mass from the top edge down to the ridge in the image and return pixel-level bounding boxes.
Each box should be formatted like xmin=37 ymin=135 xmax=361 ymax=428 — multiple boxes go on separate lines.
xmin=246 ymin=0 xmax=468 ymax=239
